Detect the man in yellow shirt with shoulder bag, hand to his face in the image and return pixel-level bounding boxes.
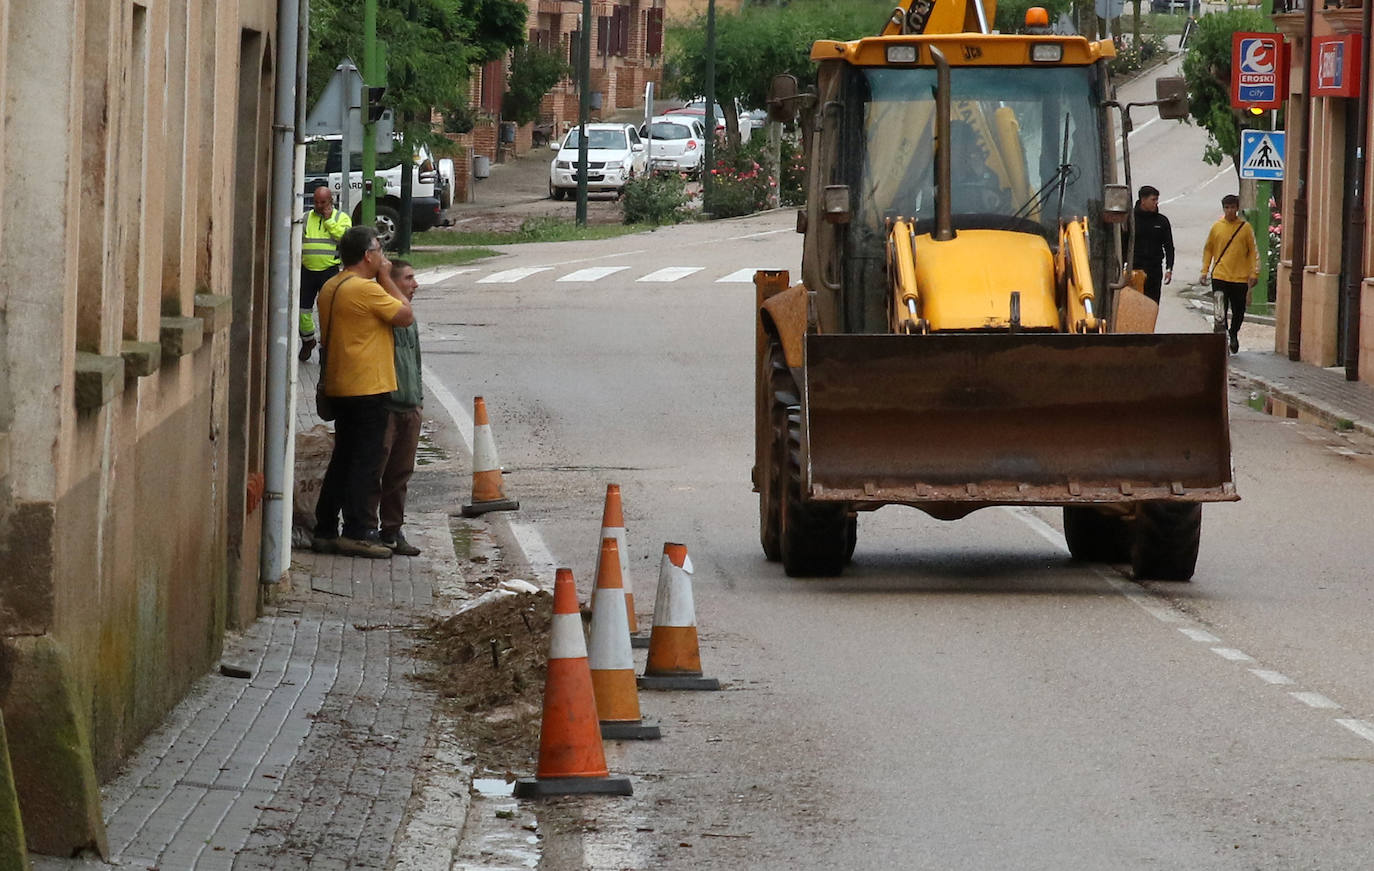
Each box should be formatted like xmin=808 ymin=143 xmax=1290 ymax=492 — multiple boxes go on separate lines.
xmin=312 ymin=227 xmax=415 ymax=559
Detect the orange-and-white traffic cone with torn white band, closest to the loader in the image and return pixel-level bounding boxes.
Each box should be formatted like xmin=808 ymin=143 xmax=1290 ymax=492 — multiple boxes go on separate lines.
xmin=639 ymin=541 xmax=720 ymax=690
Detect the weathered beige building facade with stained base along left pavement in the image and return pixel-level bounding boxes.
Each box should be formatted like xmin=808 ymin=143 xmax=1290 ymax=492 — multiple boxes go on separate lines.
xmin=0 ymin=0 xmax=278 ymax=864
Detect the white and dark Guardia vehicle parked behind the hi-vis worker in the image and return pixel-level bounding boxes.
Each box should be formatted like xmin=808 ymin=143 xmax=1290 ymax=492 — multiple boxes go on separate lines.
xmin=302 ymin=136 xmax=444 ymax=247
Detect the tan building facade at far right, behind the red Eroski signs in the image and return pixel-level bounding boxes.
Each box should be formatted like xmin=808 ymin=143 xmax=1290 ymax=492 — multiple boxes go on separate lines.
xmin=1274 ymin=0 xmax=1374 ymax=381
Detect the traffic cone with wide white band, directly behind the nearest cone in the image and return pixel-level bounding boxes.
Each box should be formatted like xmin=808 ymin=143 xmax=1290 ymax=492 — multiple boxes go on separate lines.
xmin=588 ymin=539 xmax=662 ymax=738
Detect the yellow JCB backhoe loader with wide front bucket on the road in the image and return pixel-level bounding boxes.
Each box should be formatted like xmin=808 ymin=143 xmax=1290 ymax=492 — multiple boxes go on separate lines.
xmin=754 ymin=0 xmax=1238 ymax=580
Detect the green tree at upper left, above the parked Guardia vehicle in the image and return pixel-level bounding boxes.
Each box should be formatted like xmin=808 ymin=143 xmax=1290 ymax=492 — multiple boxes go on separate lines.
xmin=306 ymin=0 xmax=528 ymax=140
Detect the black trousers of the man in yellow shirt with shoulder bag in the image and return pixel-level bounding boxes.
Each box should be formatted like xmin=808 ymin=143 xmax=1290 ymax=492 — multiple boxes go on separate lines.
xmin=315 ymin=393 xmax=390 ymax=539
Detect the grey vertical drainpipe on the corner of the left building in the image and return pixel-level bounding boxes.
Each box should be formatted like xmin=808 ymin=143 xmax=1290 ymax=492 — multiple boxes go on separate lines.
xmin=258 ymin=0 xmax=308 ymax=584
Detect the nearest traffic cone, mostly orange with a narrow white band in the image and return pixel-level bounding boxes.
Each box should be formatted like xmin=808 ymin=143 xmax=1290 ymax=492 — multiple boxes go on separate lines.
xmin=515 ymin=569 xmax=632 ymax=798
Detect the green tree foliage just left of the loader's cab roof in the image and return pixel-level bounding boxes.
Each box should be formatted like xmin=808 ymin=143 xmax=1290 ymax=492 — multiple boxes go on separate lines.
xmin=665 ymin=0 xmax=893 ymax=144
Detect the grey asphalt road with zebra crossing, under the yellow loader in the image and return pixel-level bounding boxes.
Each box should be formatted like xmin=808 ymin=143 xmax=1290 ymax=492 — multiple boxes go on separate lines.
xmin=418 ymin=59 xmax=1374 ymax=870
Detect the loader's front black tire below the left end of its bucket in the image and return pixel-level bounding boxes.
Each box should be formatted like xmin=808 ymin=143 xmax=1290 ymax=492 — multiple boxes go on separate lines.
xmin=775 ymin=407 xmax=852 ymax=577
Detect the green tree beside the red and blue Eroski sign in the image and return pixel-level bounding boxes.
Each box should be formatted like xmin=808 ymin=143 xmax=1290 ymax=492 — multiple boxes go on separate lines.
xmin=1183 ymin=8 xmax=1274 ymax=173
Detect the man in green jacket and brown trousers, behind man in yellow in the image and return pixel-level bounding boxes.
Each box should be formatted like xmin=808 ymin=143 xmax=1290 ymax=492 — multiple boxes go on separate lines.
xmin=372 ymin=260 xmax=425 ymax=556
